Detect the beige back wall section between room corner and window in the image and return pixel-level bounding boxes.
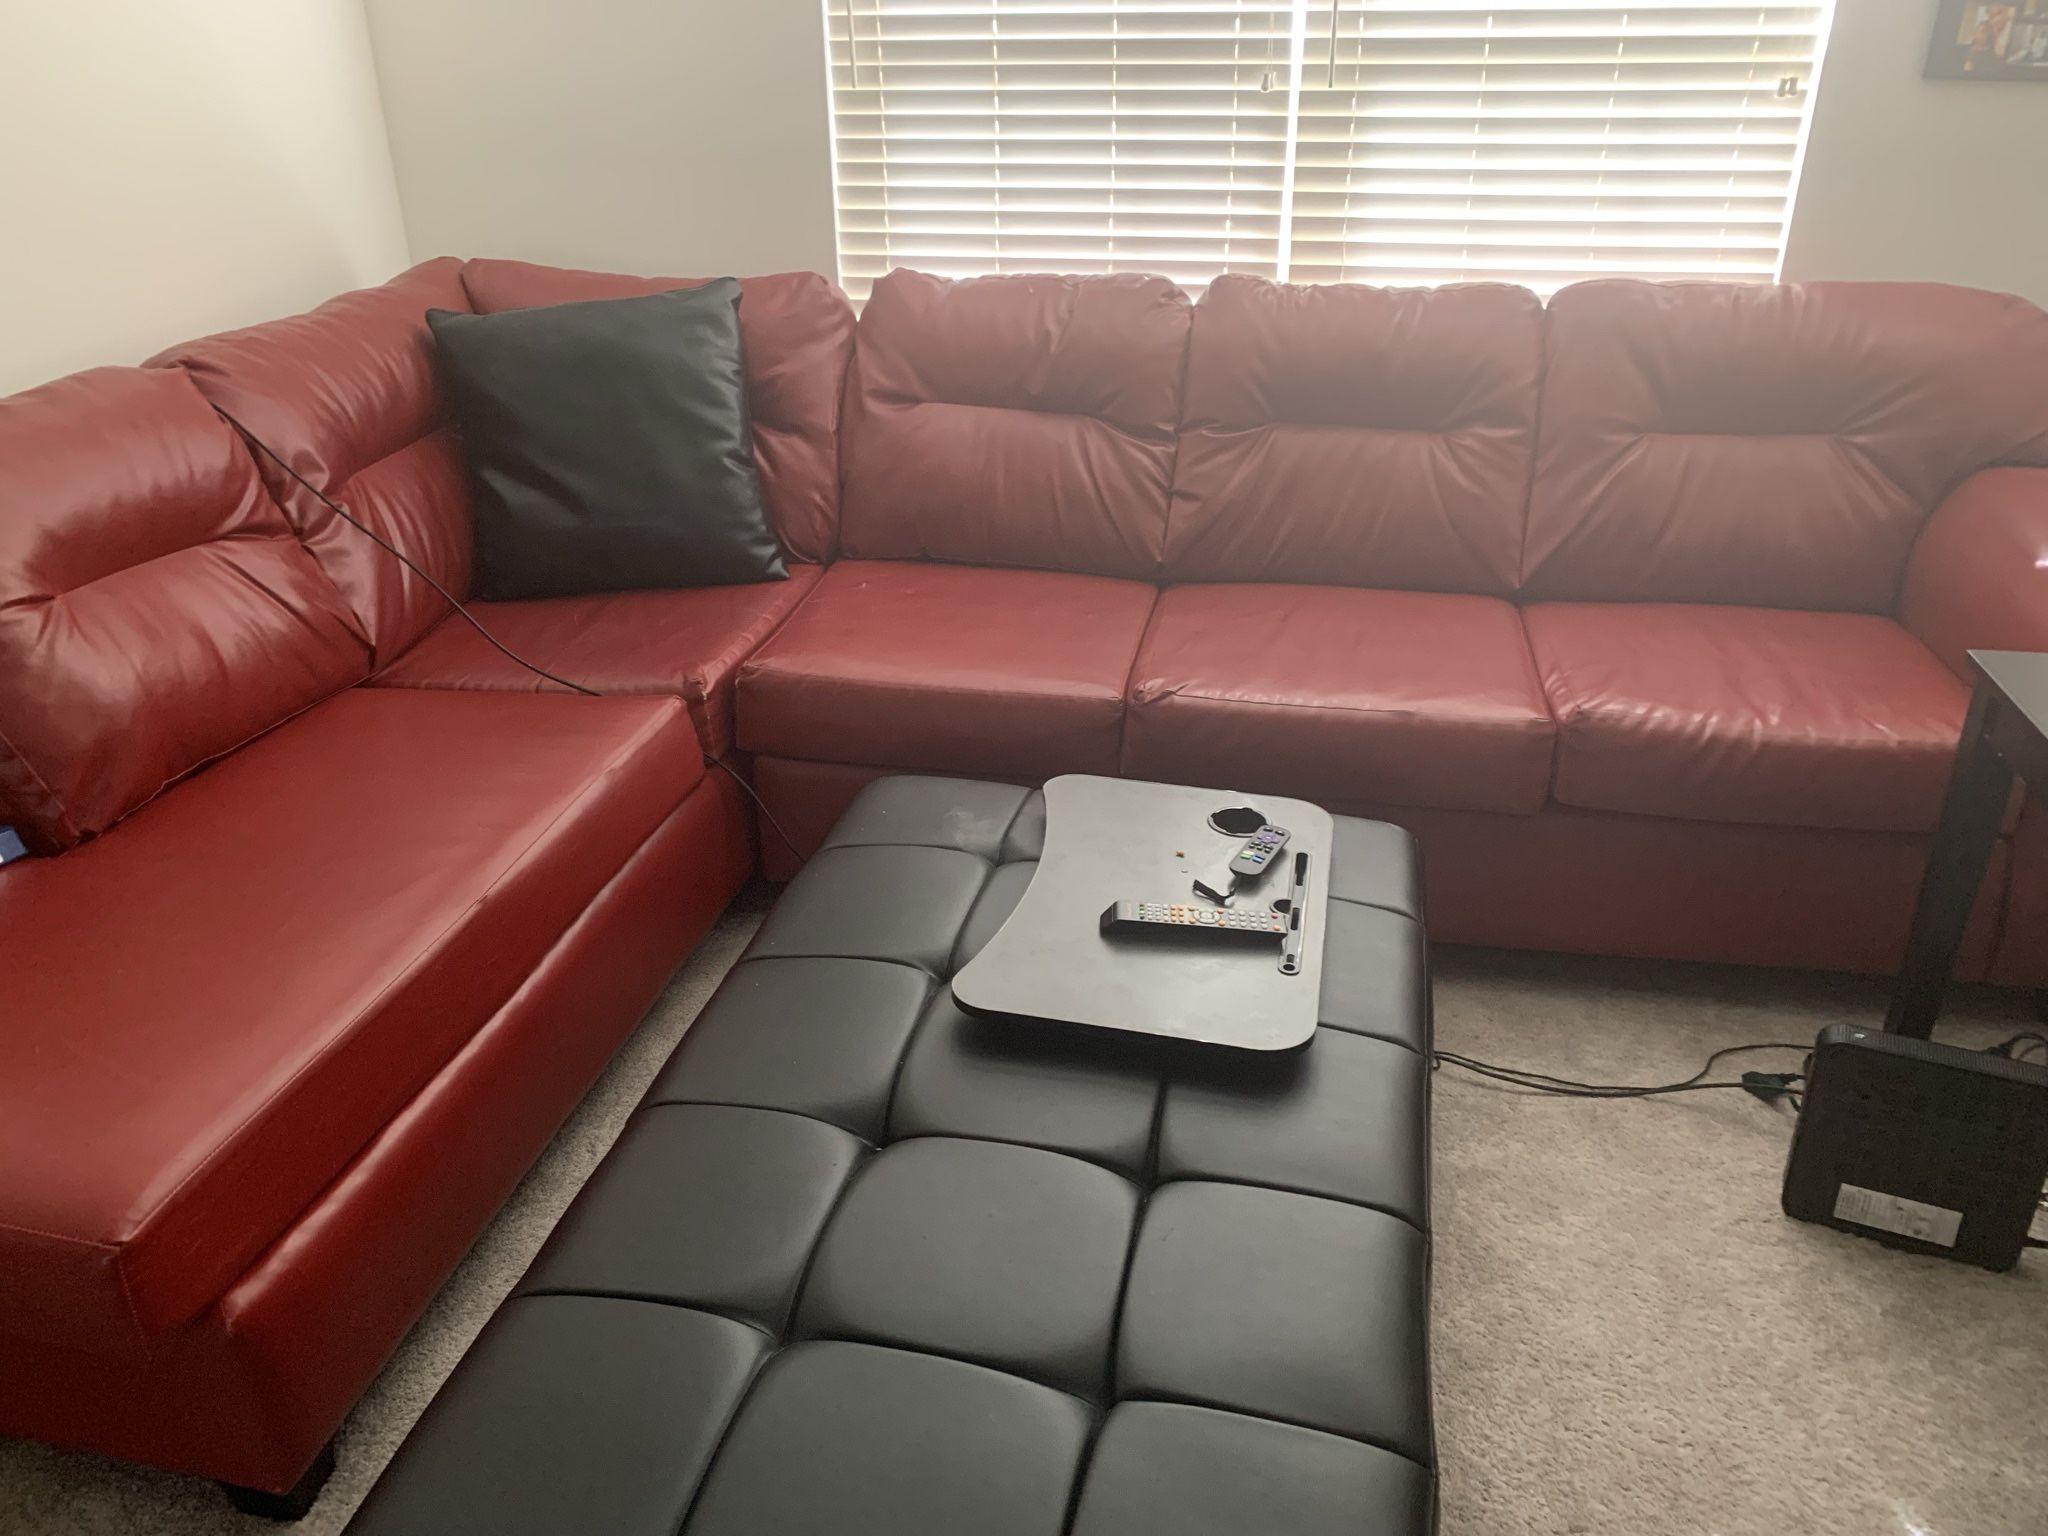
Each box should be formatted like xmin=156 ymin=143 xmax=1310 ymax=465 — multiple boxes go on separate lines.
xmin=367 ymin=0 xmax=836 ymax=276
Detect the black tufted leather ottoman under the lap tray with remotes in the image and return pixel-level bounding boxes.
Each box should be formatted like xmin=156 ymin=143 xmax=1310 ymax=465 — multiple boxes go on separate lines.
xmin=348 ymin=778 xmax=1436 ymax=1536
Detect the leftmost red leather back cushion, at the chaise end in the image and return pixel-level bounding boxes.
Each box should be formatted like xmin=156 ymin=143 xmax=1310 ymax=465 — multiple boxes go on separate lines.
xmin=0 ymin=369 xmax=369 ymax=852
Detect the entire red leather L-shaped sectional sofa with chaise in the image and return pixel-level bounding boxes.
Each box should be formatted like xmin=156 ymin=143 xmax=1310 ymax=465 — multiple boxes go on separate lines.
xmin=0 ymin=260 xmax=2048 ymax=1491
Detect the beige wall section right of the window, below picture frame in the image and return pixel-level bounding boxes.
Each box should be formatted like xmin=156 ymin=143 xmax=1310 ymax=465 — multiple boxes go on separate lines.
xmin=1784 ymin=0 xmax=2048 ymax=303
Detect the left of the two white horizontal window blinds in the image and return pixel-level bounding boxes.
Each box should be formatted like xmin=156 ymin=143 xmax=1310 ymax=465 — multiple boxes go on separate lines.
xmin=827 ymin=0 xmax=1294 ymax=299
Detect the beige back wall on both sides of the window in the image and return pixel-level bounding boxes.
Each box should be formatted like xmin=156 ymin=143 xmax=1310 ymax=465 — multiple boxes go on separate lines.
xmin=367 ymin=0 xmax=2048 ymax=301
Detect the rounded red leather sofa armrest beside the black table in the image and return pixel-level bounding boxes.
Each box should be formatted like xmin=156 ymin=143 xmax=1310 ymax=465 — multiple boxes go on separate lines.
xmin=1898 ymin=469 xmax=2048 ymax=678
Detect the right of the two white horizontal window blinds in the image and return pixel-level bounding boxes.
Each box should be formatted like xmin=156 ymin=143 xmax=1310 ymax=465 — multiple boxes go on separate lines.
xmin=1290 ymin=0 xmax=1827 ymax=291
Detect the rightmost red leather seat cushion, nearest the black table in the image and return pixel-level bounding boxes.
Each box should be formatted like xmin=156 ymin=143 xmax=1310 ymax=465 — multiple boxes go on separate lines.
xmin=1524 ymin=602 xmax=1970 ymax=831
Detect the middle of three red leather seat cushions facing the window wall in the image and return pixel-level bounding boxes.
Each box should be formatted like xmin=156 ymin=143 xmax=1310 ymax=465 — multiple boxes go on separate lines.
xmin=1122 ymin=586 xmax=1552 ymax=813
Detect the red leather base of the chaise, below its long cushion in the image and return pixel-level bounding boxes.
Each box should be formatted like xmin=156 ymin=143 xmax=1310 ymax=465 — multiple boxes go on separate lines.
xmin=0 ymin=774 xmax=754 ymax=1489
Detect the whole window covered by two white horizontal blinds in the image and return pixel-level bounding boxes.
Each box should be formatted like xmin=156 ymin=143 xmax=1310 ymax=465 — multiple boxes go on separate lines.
xmin=825 ymin=0 xmax=1831 ymax=301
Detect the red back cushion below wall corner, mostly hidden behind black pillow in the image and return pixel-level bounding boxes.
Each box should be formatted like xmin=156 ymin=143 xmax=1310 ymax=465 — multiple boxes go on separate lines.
xmin=463 ymin=260 xmax=854 ymax=561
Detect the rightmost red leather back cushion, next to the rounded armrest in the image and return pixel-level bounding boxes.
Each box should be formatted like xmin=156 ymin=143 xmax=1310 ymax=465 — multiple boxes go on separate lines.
xmin=1522 ymin=281 xmax=2048 ymax=612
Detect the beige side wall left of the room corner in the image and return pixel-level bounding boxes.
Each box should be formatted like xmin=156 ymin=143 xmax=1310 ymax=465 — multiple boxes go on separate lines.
xmin=0 ymin=0 xmax=406 ymax=393
